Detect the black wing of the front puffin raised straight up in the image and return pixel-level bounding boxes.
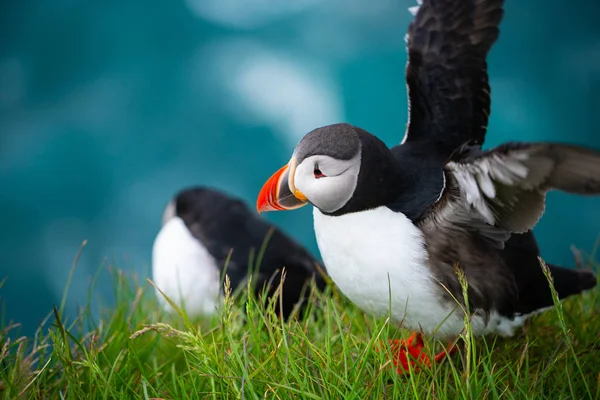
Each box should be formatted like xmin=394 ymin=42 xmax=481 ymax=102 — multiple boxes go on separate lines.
xmin=402 ymin=0 xmax=504 ymax=154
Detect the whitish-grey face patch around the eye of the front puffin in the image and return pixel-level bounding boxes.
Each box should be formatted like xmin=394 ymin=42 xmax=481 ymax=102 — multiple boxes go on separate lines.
xmin=290 ymin=152 xmax=360 ymax=213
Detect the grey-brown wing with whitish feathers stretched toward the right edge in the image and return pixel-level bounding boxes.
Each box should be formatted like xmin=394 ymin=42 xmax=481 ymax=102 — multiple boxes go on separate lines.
xmin=446 ymin=143 xmax=600 ymax=239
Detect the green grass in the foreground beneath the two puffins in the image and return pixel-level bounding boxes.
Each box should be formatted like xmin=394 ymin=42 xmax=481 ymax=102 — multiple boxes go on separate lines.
xmin=0 ymin=250 xmax=600 ymax=399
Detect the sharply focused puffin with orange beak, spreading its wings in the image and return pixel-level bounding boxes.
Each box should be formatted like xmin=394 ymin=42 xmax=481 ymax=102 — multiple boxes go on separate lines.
xmin=257 ymin=0 xmax=600 ymax=370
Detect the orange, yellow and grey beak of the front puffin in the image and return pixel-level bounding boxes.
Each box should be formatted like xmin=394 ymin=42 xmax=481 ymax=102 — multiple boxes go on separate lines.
xmin=256 ymin=157 xmax=308 ymax=213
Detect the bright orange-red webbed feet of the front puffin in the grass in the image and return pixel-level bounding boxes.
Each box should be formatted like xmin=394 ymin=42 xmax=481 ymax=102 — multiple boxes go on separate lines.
xmin=389 ymin=332 xmax=457 ymax=374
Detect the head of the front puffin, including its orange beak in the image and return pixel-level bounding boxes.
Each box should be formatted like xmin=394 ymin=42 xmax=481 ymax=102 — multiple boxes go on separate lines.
xmin=258 ymin=123 xmax=395 ymax=215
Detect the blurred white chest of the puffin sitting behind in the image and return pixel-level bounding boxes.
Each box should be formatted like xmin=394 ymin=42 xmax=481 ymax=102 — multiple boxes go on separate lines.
xmin=152 ymin=217 xmax=221 ymax=317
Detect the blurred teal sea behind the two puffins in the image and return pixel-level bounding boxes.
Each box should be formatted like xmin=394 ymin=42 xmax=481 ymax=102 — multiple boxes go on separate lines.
xmin=0 ymin=0 xmax=600 ymax=333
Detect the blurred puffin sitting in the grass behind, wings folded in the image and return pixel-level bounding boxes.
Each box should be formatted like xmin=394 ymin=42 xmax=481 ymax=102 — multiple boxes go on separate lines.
xmin=152 ymin=186 xmax=326 ymax=320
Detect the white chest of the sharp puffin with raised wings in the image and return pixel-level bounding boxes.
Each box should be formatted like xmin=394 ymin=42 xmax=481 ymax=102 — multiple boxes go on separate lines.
xmin=313 ymin=207 xmax=462 ymax=336
